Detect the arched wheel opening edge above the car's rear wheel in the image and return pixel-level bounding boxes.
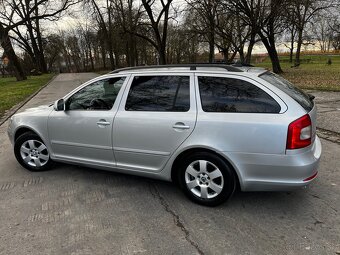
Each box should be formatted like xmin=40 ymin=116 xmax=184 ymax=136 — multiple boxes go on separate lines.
xmin=171 ymin=147 xmax=242 ymax=188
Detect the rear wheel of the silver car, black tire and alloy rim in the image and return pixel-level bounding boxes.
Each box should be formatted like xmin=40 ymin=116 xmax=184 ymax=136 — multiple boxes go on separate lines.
xmin=178 ymin=152 xmax=237 ymax=206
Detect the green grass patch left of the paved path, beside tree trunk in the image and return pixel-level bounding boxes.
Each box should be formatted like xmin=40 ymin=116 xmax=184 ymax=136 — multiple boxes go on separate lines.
xmin=0 ymin=74 xmax=54 ymax=118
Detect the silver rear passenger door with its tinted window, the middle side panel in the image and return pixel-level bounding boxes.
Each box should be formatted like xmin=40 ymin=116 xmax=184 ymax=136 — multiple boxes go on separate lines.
xmin=113 ymin=74 xmax=196 ymax=171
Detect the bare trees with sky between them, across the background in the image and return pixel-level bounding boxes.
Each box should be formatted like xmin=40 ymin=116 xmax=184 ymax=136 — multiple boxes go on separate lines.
xmin=0 ymin=0 xmax=340 ymax=80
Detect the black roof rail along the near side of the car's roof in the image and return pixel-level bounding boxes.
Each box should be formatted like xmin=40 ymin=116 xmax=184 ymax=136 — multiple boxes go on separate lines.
xmin=110 ymin=64 xmax=243 ymax=74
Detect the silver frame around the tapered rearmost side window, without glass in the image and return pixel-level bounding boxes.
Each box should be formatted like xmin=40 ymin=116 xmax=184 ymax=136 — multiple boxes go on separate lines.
xmin=195 ymin=72 xmax=288 ymax=115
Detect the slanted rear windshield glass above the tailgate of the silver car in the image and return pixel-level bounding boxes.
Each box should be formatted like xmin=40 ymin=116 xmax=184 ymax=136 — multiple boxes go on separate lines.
xmin=260 ymin=72 xmax=314 ymax=112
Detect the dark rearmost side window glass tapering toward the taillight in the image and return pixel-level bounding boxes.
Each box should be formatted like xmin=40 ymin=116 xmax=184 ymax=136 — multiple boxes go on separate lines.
xmin=198 ymin=76 xmax=281 ymax=113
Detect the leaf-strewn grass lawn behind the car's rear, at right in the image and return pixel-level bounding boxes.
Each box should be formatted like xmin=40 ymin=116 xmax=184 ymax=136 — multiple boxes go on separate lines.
xmin=254 ymin=55 xmax=340 ymax=91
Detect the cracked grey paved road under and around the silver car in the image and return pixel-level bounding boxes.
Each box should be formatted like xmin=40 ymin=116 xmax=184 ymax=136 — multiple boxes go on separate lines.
xmin=0 ymin=74 xmax=340 ymax=255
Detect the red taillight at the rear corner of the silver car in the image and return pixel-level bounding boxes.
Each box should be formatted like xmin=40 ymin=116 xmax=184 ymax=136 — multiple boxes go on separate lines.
xmin=286 ymin=114 xmax=312 ymax=150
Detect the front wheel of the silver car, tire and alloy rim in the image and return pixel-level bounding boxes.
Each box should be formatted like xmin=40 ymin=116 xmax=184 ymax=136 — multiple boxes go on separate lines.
xmin=14 ymin=132 xmax=53 ymax=172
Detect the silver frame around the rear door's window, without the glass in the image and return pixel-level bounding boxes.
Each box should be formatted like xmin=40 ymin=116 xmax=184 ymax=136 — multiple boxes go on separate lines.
xmin=119 ymin=72 xmax=196 ymax=114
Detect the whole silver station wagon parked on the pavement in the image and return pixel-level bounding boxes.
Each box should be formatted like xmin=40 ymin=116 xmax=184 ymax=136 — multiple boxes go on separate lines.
xmin=8 ymin=64 xmax=321 ymax=206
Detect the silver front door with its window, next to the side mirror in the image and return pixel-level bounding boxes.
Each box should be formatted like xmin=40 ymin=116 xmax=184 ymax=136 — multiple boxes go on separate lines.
xmin=48 ymin=76 xmax=127 ymax=166
